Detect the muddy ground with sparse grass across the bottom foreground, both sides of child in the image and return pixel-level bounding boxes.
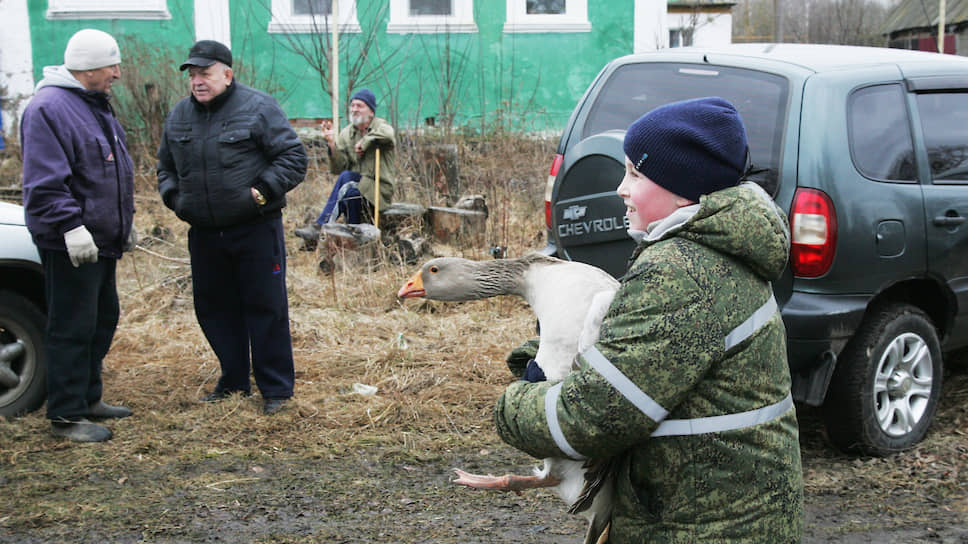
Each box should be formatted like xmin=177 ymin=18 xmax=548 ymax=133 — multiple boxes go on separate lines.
xmin=0 ymin=373 xmax=968 ymax=544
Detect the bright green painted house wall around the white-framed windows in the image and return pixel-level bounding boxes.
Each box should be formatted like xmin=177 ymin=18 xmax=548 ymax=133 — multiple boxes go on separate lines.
xmin=24 ymin=0 xmax=634 ymax=130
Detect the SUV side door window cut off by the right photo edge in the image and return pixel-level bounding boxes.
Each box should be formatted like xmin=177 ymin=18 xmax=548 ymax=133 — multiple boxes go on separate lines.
xmin=918 ymin=93 xmax=968 ymax=183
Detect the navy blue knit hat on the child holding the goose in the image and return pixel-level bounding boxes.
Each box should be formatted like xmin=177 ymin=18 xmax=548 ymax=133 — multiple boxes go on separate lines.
xmin=623 ymin=97 xmax=747 ymax=202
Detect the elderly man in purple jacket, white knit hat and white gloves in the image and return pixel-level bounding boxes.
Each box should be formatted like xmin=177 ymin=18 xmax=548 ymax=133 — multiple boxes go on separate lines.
xmin=20 ymin=29 xmax=134 ymax=442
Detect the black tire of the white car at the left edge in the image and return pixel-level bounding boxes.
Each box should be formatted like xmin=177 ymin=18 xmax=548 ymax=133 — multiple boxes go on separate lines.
xmin=0 ymin=291 xmax=47 ymax=417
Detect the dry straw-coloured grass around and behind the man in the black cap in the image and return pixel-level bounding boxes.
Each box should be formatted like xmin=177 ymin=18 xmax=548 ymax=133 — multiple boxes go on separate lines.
xmin=106 ymin=131 xmax=553 ymax=447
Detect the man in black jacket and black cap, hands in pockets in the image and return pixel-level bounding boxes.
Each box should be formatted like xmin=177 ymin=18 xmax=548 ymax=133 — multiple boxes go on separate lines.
xmin=158 ymin=40 xmax=307 ymax=414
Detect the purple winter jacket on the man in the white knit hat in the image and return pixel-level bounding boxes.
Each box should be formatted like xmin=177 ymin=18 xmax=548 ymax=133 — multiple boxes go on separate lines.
xmin=20 ymin=67 xmax=134 ymax=258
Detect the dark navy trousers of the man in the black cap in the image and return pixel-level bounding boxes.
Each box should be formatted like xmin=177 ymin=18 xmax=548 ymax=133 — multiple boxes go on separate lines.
xmin=188 ymin=216 xmax=295 ymax=398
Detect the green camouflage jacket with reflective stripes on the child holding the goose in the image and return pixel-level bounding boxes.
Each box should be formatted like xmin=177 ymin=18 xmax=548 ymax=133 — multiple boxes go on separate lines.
xmin=495 ymin=185 xmax=803 ymax=544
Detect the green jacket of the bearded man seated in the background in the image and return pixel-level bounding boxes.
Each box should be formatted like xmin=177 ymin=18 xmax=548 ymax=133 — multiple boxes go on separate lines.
xmin=329 ymin=117 xmax=397 ymax=210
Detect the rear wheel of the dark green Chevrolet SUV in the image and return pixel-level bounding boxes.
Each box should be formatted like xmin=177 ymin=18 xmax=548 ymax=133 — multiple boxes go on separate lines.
xmin=823 ymin=304 xmax=943 ymax=456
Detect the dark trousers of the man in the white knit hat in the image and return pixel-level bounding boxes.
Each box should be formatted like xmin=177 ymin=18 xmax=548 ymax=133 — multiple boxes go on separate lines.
xmin=40 ymin=249 xmax=120 ymax=419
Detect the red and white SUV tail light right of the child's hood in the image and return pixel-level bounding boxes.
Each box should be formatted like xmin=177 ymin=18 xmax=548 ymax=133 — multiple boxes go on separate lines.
xmin=790 ymin=189 xmax=837 ymax=278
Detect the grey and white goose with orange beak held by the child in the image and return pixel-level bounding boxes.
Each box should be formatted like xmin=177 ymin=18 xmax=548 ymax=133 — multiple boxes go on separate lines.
xmin=397 ymin=253 xmax=619 ymax=541
